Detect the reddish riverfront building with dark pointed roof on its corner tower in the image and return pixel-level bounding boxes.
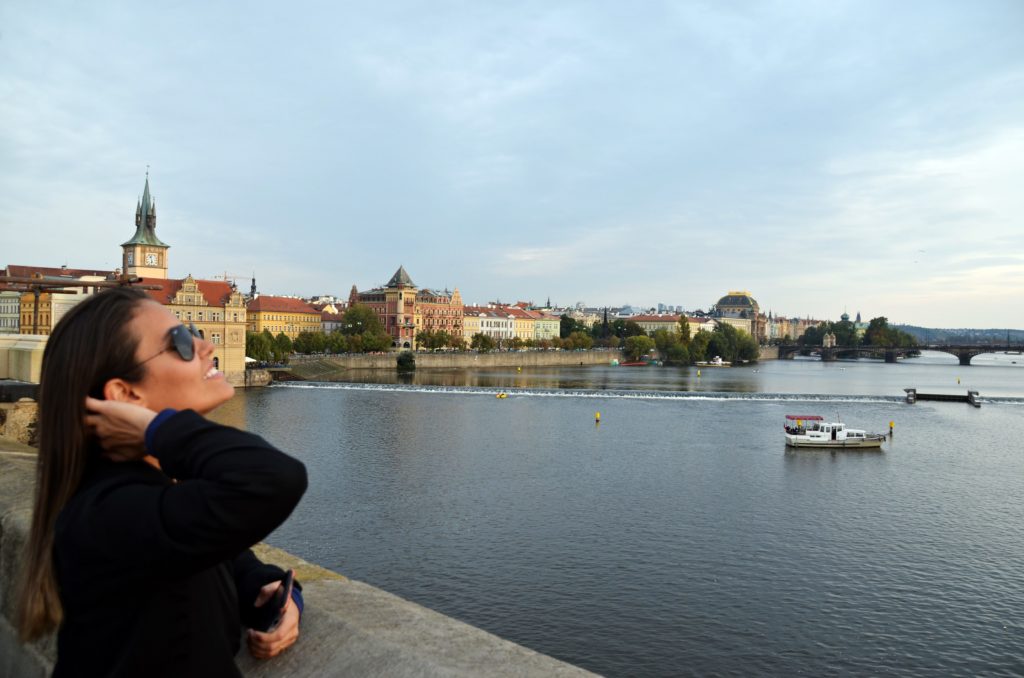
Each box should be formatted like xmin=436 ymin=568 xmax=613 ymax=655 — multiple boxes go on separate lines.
xmin=348 ymin=266 xmax=463 ymax=349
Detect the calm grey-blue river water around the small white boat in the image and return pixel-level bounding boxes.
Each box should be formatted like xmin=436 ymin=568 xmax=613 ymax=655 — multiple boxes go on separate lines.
xmin=211 ymin=355 xmax=1024 ymax=676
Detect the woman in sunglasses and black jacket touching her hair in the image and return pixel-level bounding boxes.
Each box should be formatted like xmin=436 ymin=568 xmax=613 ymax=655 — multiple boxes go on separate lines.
xmin=18 ymin=288 xmax=306 ymax=678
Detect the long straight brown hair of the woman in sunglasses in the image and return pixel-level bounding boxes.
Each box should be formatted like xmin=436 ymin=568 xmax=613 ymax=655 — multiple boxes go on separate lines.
xmin=17 ymin=288 xmax=146 ymax=641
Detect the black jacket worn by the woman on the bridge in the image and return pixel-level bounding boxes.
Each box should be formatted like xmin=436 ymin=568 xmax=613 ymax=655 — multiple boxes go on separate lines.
xmin=53 ymin=411 xmax=306 ymax=678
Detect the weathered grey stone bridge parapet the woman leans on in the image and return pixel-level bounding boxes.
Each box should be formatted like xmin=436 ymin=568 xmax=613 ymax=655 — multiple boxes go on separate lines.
xmin=0 ymin=426 xmax=593 ymax=678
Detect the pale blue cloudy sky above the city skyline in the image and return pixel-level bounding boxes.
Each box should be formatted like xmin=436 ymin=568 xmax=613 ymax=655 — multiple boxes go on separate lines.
xmin=0 ymin=0 xmax=1024 ymax=328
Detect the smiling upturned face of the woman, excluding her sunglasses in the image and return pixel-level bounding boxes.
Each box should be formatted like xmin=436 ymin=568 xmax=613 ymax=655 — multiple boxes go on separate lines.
xmin=131 ymin=301 xmax=234 ymax=415
